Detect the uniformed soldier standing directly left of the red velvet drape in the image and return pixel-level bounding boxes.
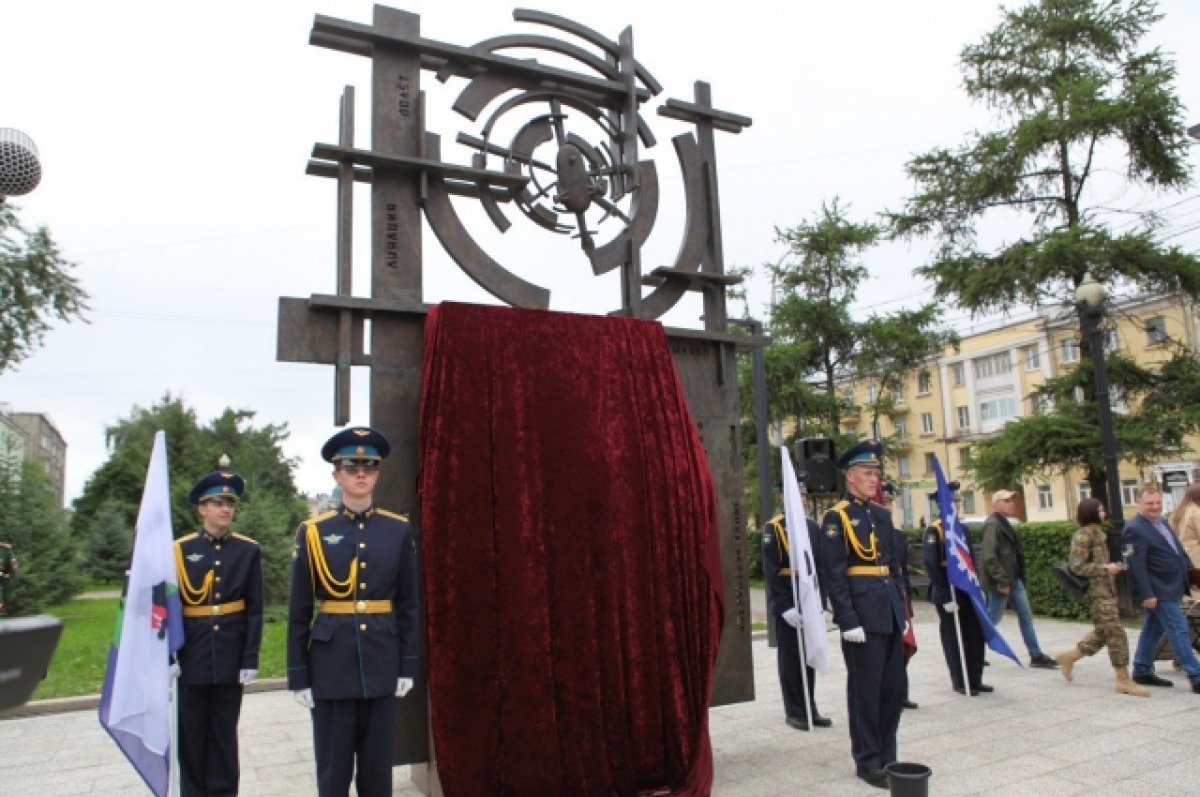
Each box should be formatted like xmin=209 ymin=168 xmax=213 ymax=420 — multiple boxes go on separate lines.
xmin=288 ymin=426 xmax=420 ymax=797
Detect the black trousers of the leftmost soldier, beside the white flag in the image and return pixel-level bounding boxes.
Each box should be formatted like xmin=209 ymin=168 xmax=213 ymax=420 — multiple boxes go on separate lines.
xmin=179 ymin=683 xmax=242 ymax=797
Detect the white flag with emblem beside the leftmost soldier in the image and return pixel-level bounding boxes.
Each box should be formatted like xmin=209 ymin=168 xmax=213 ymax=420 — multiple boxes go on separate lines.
xmin=100 ymin=431 xmax=184 ymax=797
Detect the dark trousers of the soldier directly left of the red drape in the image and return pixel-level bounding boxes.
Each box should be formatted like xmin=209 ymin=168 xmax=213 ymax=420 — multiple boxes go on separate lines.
xmin=312 ymin=695 xmax=396 ymax=797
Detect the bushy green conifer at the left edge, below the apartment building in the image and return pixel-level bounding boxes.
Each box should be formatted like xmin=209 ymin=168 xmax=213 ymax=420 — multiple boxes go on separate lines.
xmin=0 ymin=457 xmax=83 ymax=615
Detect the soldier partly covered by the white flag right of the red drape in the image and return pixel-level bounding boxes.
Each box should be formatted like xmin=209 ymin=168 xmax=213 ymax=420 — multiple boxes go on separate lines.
xmin=762 ymin=482 xmax=833 ymax=731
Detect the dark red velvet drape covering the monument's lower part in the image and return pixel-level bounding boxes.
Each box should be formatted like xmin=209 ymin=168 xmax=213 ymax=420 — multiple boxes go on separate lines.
xmin=420 ymin=304 xmax=721 ymax=797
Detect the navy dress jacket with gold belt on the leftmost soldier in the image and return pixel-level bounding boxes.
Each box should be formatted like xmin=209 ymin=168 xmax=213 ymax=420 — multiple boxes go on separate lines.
xmin=175 ymin=534 xmax=263 ymax=685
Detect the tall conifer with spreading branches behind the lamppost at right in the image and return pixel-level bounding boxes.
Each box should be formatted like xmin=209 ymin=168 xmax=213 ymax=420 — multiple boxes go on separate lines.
xmin=888 ymin=0 xmax=1200 ymax=499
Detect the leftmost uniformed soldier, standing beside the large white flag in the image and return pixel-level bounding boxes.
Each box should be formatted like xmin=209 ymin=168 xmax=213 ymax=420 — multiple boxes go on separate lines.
xmin=175 ymin=456 xmax=263 ymax=797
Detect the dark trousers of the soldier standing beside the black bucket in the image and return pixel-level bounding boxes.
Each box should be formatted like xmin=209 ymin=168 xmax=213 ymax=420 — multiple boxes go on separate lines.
xmin=841 ymin=631 xmax=907 ymax=769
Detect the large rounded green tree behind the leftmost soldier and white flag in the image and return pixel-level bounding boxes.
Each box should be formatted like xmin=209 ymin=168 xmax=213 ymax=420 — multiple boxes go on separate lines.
xmin=72 ymin=394 xmax=307 ymax=601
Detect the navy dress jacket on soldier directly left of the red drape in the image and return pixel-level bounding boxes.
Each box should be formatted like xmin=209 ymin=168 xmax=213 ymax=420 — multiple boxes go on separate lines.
xmin=288 ymin=507 xmax=420 ymax=701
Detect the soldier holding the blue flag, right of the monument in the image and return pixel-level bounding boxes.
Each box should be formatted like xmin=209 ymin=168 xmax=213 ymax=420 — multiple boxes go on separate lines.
xmin=923 ymin=481 xmax=994 ymax=695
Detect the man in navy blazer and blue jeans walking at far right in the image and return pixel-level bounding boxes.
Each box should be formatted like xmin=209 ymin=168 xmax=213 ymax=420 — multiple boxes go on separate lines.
xmin=1121 ymin=485 xmax=1200 ymax=694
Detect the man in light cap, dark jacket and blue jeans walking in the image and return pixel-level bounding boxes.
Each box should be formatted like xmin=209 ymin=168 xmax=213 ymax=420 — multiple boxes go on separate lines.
xmin=978 ymin=490 xmax=1058 ymax=670
